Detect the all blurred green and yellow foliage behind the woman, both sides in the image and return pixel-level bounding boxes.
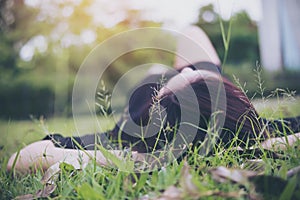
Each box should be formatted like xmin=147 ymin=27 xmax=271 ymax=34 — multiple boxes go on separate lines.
xmin=0 ymin=0 xmax=300 ymax=119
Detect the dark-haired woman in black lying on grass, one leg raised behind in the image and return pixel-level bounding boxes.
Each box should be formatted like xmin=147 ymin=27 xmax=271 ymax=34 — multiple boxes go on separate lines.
xmin=7 ymin=27 xmax=300 ymax=172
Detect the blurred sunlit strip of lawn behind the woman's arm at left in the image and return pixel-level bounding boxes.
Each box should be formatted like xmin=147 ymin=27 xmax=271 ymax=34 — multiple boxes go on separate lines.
xmin=0 ymin=116 xmax=114 ymax=157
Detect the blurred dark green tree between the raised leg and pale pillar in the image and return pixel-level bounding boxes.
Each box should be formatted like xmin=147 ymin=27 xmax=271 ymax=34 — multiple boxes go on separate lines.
xmin=196 ymin=5 xmax=260 ymax=67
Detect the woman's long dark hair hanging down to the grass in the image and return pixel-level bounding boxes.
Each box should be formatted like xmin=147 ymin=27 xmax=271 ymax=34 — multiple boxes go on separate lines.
xmin=110 ymin=65 xmax=265 ymax=152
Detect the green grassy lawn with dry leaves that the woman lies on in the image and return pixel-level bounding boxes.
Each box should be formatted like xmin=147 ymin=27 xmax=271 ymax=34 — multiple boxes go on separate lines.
xmin=0 ymin=98 xmax=300 ymax=199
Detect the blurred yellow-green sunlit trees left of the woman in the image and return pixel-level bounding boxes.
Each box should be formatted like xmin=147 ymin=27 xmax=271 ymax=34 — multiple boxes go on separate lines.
xmin=0 ymin=0 xmax=166 ymax=118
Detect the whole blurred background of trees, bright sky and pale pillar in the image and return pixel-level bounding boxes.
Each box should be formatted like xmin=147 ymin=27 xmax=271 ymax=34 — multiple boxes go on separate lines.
xmin=0 ymin=0 xmax=300 ymax=120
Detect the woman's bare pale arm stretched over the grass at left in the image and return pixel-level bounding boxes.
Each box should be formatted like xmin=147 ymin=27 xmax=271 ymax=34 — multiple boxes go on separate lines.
xmin=7 ymin=140 xmax=141 ymax=173
